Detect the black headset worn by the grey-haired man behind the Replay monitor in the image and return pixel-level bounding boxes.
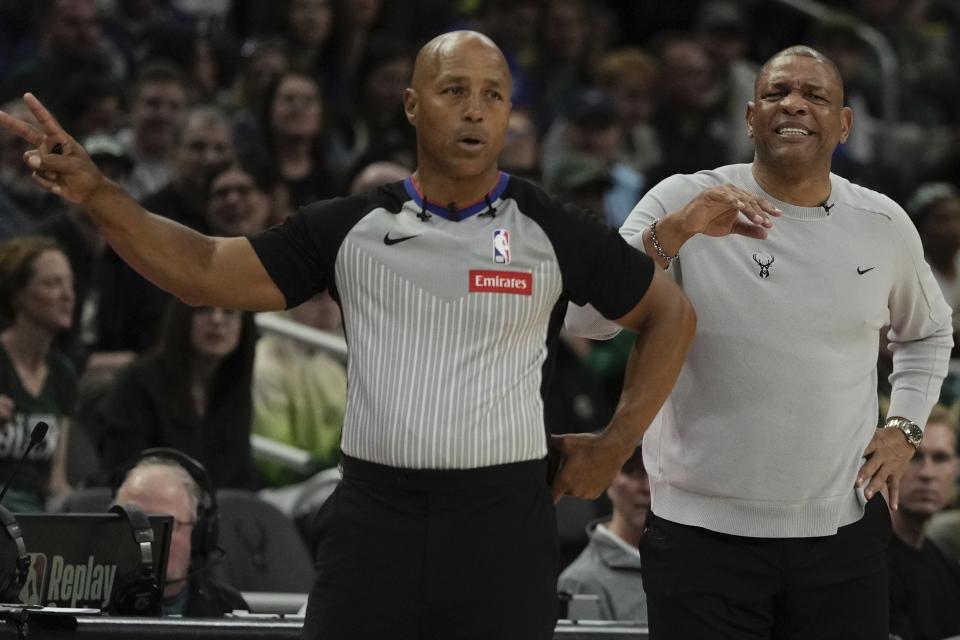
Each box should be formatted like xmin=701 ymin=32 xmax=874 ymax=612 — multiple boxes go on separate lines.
xmin=114 ymin=447 xmax=223 ymax=573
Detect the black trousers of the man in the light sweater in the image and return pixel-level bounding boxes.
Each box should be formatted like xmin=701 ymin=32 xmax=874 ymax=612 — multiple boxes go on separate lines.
xmin=640 ymin=494 xmax=891 ymax=640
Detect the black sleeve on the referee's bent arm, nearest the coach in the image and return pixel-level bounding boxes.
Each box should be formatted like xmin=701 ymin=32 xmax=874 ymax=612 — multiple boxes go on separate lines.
xmin=535 ymin=189 xmax=655 ymax=320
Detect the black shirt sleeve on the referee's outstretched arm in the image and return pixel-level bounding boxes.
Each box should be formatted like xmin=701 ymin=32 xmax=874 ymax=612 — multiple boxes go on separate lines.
xmin=250 ymin=195 xmax=372 ymax=308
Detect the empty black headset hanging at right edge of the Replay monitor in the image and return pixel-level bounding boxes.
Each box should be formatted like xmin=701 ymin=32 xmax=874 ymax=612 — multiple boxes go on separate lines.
xmin=110 ymin=504 xmax=162 ymax=616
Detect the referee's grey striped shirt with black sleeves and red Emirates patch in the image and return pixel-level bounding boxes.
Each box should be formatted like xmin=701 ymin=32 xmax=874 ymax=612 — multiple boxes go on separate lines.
xmin=251 ymin=173 xmax=653 ymax=469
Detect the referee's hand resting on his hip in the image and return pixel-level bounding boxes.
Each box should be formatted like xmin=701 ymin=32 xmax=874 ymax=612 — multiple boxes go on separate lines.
xmin=551 ymin=433 xmax=636 ymax=502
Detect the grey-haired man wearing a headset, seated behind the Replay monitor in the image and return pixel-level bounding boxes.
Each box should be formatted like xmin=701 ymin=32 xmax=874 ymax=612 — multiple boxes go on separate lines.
xmin=116 ymin=454 xmax=250 ymax=618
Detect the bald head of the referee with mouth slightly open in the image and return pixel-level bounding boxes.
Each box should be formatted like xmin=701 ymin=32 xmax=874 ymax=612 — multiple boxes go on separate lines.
xmin=404 ymin=33 xmax=512 ymax=178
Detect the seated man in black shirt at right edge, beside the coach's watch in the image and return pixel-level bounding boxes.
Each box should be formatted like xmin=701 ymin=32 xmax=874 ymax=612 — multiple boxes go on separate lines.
xmin=888 ymin=406 xmax=960 ymax=640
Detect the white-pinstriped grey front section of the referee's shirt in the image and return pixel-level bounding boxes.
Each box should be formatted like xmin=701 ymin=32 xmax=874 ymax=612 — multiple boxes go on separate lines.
xmin=337 ymin=239 xmax=562 ymax=469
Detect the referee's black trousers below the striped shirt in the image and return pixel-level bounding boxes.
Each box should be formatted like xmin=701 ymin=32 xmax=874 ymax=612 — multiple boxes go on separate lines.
xmin=303 ymin=457 xmax=557 ymax=640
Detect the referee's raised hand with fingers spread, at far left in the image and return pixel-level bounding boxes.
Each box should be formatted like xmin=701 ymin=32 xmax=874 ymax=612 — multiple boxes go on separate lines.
xmin=0 ymin=93 xmax=106 ymax=205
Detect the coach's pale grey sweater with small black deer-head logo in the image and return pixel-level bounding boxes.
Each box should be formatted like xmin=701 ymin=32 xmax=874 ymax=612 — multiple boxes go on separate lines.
xmin=571 ymin=164 xmax=952 ymax=537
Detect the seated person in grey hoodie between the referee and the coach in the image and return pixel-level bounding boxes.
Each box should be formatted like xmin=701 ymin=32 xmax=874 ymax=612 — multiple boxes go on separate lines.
xmin=557 ymin=447 xmax=650 ymax=623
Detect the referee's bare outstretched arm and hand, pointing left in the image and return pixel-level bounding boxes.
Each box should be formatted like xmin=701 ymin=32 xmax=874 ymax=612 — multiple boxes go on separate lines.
xmin=0 ymin=93 xmax=285 ymax=311
